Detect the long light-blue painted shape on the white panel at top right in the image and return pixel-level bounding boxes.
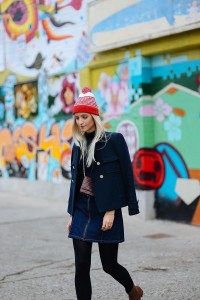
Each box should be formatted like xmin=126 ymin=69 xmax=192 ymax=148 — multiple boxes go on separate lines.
xmin=90 ymin=0 xmax=200 ymax=44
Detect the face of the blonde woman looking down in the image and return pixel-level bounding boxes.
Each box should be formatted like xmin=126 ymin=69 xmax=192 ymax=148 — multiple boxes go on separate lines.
xmin=75 ymin=113 xmax=96 ymax=132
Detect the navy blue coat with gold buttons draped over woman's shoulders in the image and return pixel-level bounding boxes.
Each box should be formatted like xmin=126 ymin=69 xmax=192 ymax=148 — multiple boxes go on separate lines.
xmin=68 ymin=132 xmax=139 ymax=215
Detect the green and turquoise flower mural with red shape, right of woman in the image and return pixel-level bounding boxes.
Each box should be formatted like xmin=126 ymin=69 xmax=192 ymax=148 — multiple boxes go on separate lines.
xmin=92 ymin=51 xmax=200 ymax=225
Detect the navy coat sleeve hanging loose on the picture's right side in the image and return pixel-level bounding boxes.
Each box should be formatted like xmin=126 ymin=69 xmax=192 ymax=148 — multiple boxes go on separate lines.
xmin=112 ymin=133 xmax=139 ymax=215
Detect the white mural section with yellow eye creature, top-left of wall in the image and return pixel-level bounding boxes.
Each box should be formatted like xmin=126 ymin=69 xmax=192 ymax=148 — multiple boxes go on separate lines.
xmin=0 ymin=0 xmax=90 ymax=77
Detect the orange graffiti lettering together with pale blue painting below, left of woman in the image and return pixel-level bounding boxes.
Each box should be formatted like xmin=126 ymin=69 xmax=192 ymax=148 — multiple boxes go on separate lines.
xmin=0 ymin=120 xmax=72 ymax=182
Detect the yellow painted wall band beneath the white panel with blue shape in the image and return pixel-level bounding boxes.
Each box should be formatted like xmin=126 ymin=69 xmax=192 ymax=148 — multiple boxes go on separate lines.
xmin=80 ymin=30 xmax=200 ymax=95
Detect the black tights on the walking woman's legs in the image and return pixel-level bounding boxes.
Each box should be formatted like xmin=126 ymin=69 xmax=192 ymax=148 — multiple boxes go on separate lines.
xmin=73 ymin=239 xmax=133 ymax=300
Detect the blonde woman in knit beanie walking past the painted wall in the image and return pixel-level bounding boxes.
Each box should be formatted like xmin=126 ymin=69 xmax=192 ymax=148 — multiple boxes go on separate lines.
xmin=67 ymin=87 xmax=143 ymax=300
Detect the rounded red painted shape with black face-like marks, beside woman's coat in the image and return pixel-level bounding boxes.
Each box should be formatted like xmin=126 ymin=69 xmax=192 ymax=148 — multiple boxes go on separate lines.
xmin=132 ymin=148 xmax=165 ymax=190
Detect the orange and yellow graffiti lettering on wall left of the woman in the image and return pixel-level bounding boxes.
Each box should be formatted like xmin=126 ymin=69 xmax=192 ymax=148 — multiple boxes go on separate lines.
xmin=0 ymin=120 xmax=72 ymax=176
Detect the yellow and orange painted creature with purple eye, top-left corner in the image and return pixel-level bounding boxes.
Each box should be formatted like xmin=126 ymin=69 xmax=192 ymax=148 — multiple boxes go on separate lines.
xmin=1 ymin=0 xmax=83 ymax=43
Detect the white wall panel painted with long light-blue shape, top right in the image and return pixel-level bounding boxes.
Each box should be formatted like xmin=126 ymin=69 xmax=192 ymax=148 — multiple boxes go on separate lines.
xmin=89 ymin=0 xmax=200 ymax=51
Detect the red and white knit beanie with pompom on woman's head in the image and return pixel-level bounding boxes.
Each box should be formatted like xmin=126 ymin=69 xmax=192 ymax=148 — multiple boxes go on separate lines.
xmin=73 ymin=87 xmax=99 ymax=116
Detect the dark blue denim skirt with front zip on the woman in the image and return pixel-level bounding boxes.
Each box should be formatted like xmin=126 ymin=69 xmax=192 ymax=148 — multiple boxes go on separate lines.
xmin=68 ymin=193 xmax=124 ymax=243
